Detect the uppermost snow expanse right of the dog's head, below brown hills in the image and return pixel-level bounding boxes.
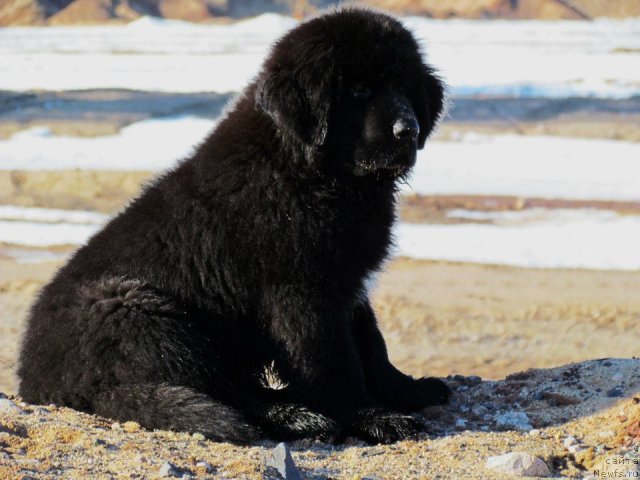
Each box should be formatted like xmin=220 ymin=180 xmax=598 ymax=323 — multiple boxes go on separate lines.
xmin=405 ymin=17 xmax=640 ymax=98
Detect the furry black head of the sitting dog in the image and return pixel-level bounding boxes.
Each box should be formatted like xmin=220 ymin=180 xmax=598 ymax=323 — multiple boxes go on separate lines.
xmin=256 ymin=8 xmax=443 ymax=176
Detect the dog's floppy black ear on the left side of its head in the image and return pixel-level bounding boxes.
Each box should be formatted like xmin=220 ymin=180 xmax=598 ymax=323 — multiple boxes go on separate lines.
xmin=255 ymin=55 xmax=334 ymax=147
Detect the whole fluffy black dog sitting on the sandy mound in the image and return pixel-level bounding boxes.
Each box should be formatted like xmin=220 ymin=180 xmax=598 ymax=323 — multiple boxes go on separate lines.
xmin=18 ymin=8 xmax=449 ymax=443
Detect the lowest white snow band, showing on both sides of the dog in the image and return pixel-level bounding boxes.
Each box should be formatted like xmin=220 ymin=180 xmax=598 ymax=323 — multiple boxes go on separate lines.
xmin=0 ymin=206 xmax=640 ymax=270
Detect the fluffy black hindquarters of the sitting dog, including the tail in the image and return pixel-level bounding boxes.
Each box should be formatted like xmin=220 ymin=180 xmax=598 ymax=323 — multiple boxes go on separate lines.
xmin=19 ymin=277 xmax=259 ymax=443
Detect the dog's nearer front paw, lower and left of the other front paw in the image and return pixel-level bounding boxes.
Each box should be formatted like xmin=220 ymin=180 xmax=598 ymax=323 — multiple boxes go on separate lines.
xmin=349 ymin=408 xmax=424 ymax=443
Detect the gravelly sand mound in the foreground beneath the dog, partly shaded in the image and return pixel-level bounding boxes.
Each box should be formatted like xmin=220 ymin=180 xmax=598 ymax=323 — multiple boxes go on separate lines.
xmin=0 ymin=359 xmax=640 ymax=479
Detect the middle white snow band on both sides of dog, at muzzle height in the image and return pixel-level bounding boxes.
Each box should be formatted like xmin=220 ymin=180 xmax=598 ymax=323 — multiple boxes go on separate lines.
xmin=0 ymin=120 xmax=640 ymax=201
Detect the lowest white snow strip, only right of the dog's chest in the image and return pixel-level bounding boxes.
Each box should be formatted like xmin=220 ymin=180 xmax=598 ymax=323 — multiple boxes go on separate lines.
xmin=396 ymin=209 xmax=640 ymax=270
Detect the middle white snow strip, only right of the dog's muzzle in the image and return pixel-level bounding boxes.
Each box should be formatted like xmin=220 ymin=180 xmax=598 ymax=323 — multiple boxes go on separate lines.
xmin=410 ymin=134 xmax=640 ymax=201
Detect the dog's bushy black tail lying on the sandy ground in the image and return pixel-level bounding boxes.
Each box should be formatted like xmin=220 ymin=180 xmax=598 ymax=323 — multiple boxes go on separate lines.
xmin=93 ymin=384 xmax=260 ymax=444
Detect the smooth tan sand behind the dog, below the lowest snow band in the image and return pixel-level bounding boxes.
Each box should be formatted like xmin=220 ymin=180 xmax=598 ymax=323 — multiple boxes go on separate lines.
xmin=0 ymin=256 xmax=640 ymax=393
